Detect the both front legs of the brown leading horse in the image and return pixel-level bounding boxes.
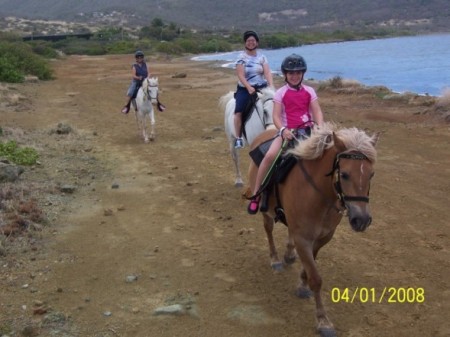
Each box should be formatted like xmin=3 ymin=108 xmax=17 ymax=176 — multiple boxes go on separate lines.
xmin=296 ymin=240 xmax=336 ymax=337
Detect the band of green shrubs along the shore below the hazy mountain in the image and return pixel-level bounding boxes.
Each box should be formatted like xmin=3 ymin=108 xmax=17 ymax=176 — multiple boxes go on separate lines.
xmin=0 ymin=18 xmax=410 ymax=83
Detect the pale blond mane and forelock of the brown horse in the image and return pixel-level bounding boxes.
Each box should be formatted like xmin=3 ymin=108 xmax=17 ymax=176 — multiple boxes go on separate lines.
xmin=288 ymin=122 xmax=377 ymax=163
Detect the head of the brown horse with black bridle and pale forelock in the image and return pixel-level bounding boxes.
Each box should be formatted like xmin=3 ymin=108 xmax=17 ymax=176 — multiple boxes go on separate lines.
xmin=333 ymin=128 xmax=378 ymax=232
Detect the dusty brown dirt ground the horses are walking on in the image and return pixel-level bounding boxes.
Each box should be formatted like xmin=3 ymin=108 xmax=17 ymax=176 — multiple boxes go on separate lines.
xmin=0 ymin=56 xmax=450 ymax=337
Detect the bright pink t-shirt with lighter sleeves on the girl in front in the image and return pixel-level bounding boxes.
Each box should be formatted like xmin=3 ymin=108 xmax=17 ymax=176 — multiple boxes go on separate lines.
xmin=273 ymin=84 xmax=318 ymax=129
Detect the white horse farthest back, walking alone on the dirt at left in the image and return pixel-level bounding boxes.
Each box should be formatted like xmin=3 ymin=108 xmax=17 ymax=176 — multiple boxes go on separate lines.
xmin=133 ymin=77 xmax=158 ymax=143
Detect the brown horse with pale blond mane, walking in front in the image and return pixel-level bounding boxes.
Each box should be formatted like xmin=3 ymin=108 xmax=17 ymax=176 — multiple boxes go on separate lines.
xmin=249 ymin=123 xmax=378 ymax=337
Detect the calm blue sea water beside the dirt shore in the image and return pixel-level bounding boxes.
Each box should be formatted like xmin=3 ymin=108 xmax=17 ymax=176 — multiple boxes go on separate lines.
xmin=193 ymin=33 xmax=450 ymax=96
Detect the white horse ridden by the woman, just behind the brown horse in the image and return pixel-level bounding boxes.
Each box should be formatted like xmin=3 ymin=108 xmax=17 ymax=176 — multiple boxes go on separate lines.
xmin=219 ymin=88 xmax=275 ymax=187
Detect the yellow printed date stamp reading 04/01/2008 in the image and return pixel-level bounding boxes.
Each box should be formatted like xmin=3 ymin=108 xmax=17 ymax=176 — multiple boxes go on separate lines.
xmin=331 ymin=287 xmax=425 ymax=303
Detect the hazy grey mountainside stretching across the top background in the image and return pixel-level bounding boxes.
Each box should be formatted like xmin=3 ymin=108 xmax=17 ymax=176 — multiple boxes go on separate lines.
xmin=0 ymin=0 xmax=450 ymax=32
